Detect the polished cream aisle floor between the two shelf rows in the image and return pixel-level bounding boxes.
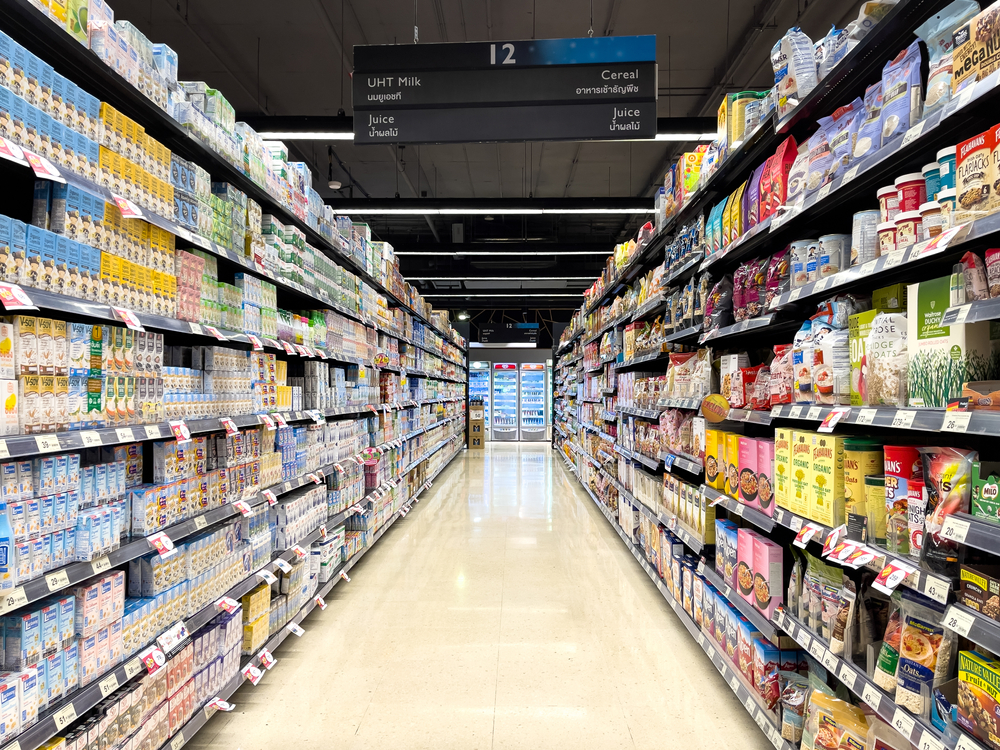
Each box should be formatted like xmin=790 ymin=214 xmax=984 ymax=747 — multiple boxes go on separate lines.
xmin=195 ymin=443 xmax=771 ymax=750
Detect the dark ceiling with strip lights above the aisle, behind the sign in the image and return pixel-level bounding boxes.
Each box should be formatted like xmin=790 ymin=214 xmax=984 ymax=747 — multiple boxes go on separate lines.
xmin=113 ymin=0 xmax=860 ymax=320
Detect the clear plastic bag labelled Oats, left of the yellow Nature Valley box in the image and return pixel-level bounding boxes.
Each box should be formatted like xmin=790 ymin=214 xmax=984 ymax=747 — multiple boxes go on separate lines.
xmin=895 ymin=589 xmax=958 ymax=718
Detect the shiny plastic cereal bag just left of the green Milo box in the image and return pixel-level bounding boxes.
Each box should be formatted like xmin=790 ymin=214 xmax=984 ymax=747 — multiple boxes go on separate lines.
xmin=918 ymin=448 xmax=979 ymax=576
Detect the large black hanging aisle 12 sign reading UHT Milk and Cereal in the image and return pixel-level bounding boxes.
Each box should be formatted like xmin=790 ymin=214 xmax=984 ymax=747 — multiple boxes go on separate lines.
xmin=352 ymin=35 xmax=657 ymax=143
